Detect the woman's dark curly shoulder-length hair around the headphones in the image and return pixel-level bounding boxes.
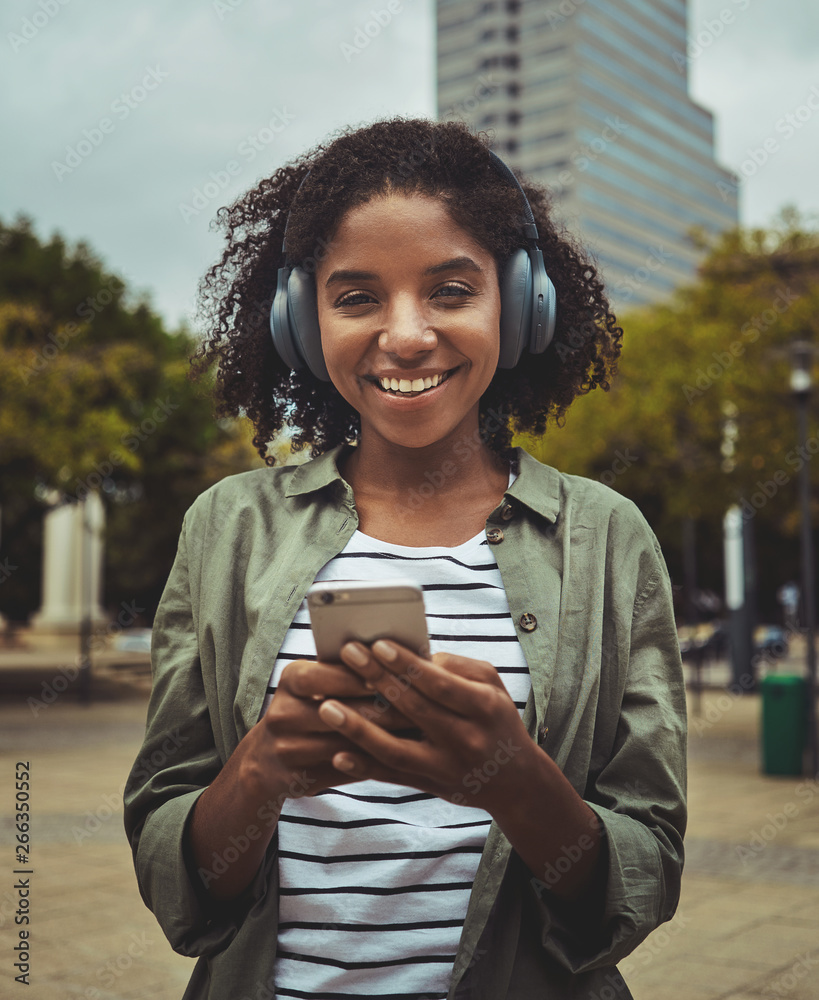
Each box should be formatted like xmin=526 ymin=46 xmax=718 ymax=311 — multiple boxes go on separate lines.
xmin=191 ymin=118 xmax=622 ymax=465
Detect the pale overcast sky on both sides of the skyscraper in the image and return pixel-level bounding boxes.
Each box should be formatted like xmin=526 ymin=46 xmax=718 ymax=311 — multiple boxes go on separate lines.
xmin=0 ymin=0 xmax=819 ymax=324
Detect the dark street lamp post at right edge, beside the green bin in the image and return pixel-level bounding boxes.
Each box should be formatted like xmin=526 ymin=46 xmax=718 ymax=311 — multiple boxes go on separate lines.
xmin=791 ymin=340 xmax=819 ymax=777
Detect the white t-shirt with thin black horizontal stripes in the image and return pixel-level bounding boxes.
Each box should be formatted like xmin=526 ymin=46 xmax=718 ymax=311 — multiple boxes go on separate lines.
xmin=263 ymin=488 xmax=531 ymax=1000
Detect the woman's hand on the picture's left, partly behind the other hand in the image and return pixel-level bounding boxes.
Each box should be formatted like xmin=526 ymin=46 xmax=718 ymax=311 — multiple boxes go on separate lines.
xmin=237 ymin=660 xmax=412 ymax=797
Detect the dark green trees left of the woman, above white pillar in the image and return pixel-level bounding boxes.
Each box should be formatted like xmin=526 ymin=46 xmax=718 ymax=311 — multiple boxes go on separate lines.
xmin=0 ymin=218 xmax=259 ymax=622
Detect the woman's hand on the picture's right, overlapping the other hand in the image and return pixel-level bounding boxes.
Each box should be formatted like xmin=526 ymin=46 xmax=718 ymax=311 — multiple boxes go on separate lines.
xmin=318 ymin=640 xmax=540 ymax=816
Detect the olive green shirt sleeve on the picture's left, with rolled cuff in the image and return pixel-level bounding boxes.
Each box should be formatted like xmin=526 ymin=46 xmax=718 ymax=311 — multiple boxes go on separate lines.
xmin=124 ymin=516 xmax=270 ymax=957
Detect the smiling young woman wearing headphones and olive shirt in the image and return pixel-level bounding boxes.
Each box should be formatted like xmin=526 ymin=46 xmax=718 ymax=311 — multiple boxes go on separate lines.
xmin=126 ymin=119 xmax=685 ymax=1000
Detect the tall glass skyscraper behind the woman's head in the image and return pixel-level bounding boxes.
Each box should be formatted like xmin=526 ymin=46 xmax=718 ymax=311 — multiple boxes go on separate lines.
xmin=437 ymin=0 xmax=737 ymax=309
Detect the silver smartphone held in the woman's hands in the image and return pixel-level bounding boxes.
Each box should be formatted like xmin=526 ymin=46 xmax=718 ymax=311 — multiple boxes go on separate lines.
xmin=307 ymin=580 xmax=430 ymax=663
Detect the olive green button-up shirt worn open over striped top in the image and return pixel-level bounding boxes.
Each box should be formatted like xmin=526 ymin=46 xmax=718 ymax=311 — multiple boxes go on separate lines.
xmin=125 ymin=446 xmax=686 ymax=1000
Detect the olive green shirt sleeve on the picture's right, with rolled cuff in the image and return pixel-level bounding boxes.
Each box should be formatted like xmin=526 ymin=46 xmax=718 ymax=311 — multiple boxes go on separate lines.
xmin=532 ymin=535 xmax=687 ymax=973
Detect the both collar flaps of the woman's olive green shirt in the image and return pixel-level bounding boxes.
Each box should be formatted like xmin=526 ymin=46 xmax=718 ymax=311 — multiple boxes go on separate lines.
xmin=286 ymin=444 xmax=560 ymax=521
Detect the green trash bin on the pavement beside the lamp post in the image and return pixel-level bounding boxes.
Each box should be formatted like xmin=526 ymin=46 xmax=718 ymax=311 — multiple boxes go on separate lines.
xmin=760 ymin=674 xmax=807 ymax=774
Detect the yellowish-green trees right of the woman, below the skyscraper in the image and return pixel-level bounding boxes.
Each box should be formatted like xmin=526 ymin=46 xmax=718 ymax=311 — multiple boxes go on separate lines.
xmin=527 ymin=211 xmax=819 ymax=615
